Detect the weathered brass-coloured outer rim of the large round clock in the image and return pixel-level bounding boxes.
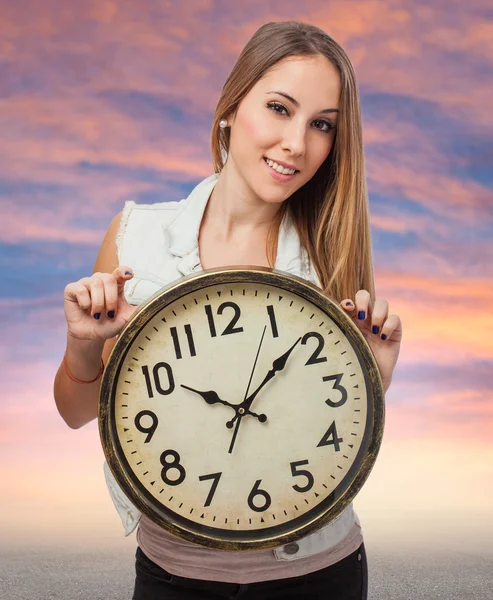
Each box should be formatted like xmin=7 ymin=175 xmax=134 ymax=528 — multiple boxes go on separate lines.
xmin=98 ymin=266 xmax=385 ymax=550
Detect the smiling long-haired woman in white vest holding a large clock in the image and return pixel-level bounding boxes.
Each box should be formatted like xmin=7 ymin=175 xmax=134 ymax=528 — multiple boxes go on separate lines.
xmin=55 ymin=22 xmax=402 ymax=600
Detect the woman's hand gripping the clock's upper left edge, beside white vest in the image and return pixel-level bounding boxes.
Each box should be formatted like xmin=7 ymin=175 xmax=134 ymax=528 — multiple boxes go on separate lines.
xmin=63 ymin=266 xmax=138 ymax=341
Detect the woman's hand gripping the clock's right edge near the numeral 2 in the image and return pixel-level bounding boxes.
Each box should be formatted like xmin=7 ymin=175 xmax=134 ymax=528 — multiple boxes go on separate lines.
xmin=340 ymin=290 xmax=402 ymax=391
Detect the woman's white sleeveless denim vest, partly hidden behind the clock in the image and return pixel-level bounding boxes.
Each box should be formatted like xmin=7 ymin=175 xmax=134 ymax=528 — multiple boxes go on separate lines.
xmin=104 ymin=174 xmax=359 ymax=560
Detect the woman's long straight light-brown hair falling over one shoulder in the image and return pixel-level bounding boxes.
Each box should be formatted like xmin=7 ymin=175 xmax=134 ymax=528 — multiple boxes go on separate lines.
xmin=211 ymin=21 xmax=375 ymax=302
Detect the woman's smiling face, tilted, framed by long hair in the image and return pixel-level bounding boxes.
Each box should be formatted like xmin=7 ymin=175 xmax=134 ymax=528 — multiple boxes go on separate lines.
xmin=225 ymin=55 xmax=340 ymax=202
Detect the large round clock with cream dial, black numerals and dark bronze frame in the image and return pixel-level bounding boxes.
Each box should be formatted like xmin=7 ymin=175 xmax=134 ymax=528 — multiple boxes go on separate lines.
xmin=100 ymin=271 xmax=380 ymax=548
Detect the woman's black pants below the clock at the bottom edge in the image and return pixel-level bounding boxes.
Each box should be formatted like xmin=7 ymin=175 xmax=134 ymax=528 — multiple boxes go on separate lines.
xmin=132 ymin=544 xmax=368 ymax=600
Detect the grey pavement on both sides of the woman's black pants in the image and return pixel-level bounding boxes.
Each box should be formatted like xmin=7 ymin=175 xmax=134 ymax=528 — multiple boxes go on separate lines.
xmin=0 ymin=543 xmax=493 ymax=600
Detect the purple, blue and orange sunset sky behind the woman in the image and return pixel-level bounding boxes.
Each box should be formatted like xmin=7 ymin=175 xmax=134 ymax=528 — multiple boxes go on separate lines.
xmin=0 ymin=0 xmax=493 ymax=598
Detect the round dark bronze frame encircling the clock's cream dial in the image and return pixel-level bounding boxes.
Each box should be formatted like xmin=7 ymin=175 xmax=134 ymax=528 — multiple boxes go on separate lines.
xmin=98 ymin=266 xmax=384 ymax=551
